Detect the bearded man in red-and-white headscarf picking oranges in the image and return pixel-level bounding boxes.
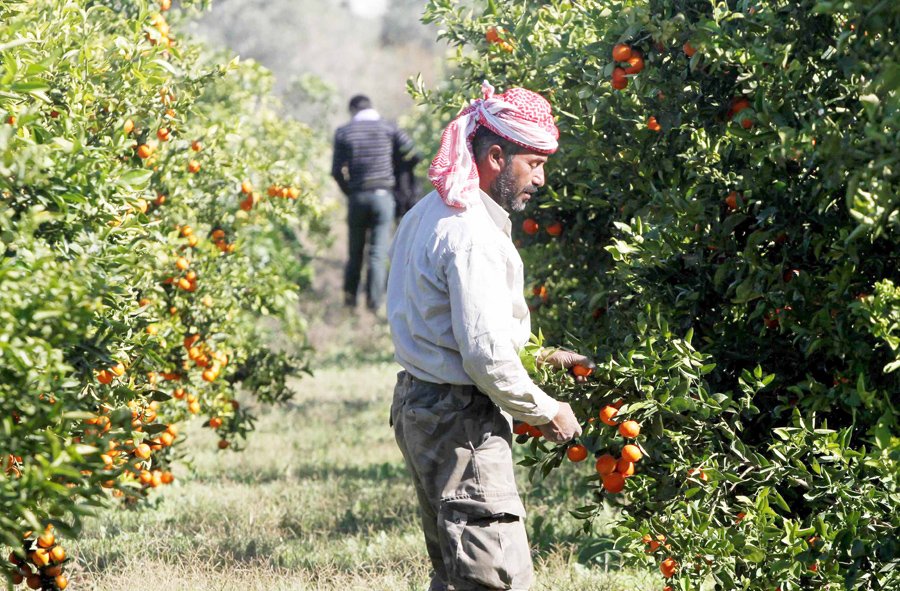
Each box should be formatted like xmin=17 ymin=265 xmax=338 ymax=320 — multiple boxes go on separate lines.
xmin=387 ymin=82 xmax=594 ymax=591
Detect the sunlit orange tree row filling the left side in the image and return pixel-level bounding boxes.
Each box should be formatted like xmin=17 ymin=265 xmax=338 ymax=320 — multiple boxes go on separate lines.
xmin=0 ymin=0 xmax=321 ymax=589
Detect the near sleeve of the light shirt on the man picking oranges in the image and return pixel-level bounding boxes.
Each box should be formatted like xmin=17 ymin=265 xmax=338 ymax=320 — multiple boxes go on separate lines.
xmin=444 ymin=243 xmax=559 ymax=425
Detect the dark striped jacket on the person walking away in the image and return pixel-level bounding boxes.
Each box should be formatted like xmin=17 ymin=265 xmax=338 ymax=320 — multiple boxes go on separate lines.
xmin=331 ymin=118 xmax=414 ymax=195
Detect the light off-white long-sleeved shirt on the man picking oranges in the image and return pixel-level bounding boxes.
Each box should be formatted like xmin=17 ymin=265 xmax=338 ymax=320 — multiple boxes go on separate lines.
xmin=387 ymin=191 xmax=559 ymax=425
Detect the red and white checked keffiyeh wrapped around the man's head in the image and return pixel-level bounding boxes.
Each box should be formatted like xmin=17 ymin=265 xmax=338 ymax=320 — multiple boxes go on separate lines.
xmin=428 ymin=81 xmax=559 ymax=209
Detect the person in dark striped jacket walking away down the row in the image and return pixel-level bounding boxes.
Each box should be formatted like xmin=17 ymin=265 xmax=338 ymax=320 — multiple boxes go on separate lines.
xmin=331 ymin=95 xmax=420 ymax=312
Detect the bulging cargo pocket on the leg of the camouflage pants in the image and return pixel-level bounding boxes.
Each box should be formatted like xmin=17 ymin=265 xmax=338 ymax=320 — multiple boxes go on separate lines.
xmin=438 ymin=498 xmax=532 ymax=590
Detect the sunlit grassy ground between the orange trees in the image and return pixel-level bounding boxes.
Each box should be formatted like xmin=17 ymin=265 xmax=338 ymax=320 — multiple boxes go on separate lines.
xmin=65 ymin=362 xmax=656 ymax=591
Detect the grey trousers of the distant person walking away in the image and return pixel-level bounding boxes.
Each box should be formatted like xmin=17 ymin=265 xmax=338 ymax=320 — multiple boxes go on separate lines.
xmin=344 ymin=189 xmax=394 ymax=310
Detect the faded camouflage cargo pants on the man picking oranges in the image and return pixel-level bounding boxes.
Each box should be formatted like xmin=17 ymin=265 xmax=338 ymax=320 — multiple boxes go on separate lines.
xmin=391 ymin=371 xmax=533 ymax=591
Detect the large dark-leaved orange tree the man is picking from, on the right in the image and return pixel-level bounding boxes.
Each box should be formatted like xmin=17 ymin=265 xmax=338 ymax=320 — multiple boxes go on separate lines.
xmin=419 ymin=0 xmax=900 ymax=591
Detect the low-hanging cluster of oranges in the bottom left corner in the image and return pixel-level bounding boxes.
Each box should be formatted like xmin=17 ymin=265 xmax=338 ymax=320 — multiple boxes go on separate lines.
xmin=9 ymin=525 xmax=69 ymax=591
